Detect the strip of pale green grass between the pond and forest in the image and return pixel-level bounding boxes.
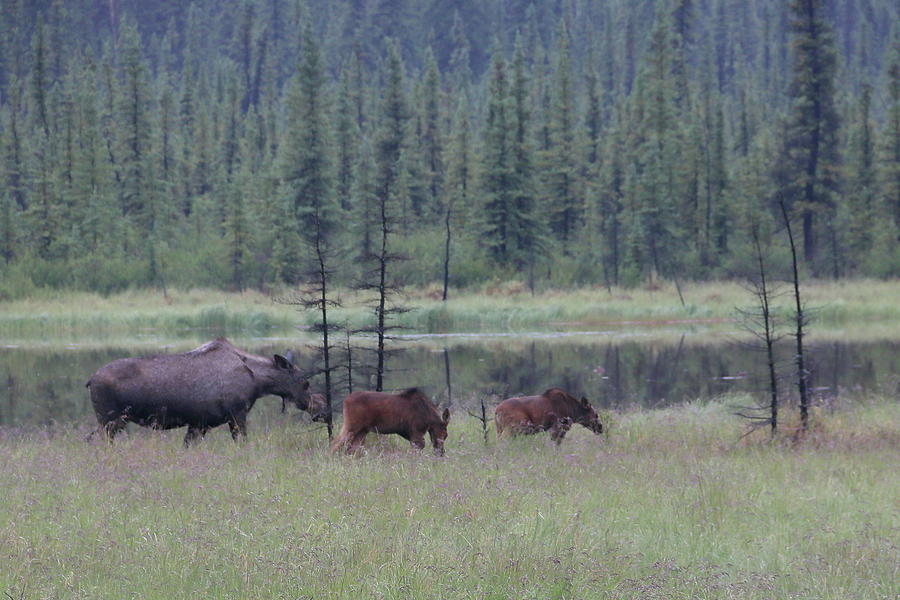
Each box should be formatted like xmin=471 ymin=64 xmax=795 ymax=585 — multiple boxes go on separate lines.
xmin=0 ymin=280 xmax=900 ymax=342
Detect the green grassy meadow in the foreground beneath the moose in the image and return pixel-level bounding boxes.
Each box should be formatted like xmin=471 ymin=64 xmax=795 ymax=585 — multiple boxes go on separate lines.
xmin=0 ymin=399 xmax=900 ymax=600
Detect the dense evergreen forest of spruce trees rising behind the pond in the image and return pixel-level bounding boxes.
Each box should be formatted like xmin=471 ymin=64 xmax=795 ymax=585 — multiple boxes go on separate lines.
xmin=0 ymin=0 xmax=900 ymax=298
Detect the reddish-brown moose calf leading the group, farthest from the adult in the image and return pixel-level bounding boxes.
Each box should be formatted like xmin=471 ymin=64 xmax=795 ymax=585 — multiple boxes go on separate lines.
xmin=494 ymin=388 xmax=603 ymax=444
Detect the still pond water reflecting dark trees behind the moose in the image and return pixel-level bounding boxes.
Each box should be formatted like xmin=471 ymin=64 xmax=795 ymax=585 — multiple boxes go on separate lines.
xmin=0 ymin=332 xmax=900 ymax=426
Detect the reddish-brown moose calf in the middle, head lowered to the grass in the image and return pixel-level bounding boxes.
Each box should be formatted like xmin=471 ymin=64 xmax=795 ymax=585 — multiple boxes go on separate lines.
xmin=331 ymin=388 xmax=450 ymax=456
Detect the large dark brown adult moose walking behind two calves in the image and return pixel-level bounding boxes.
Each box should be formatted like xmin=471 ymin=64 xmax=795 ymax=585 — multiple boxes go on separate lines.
xmin=87 ymin=338 xmax=309 ymax=446
